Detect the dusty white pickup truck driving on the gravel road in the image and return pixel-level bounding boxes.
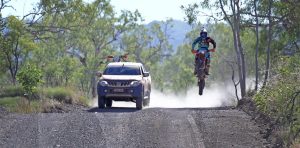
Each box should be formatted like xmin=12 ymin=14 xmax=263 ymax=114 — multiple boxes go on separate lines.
xmin=97 ymin=62 xmax=151 ymax=109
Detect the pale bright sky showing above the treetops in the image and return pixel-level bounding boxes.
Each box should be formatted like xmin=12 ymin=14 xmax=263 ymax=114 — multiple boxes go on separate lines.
xmin=3 ymin=0 xmax=199 ymax=23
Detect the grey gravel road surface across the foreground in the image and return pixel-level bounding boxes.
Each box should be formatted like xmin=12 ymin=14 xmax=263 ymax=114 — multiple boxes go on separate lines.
xmin=0 ymin=108 xmax=266 ymax=148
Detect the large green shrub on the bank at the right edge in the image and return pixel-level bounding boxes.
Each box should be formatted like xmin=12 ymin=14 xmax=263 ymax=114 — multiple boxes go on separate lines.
xmin=254 ymin=56 xmax=300 ymax=147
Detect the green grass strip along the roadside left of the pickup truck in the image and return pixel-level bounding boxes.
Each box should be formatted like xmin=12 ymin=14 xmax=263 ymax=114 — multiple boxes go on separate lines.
xmin=0 ymin=86 xmax=90 ymax=113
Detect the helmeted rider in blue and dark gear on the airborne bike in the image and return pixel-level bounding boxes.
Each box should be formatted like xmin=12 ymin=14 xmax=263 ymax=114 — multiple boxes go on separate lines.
xmin=192 ymin=28 xmax=216 ymax=75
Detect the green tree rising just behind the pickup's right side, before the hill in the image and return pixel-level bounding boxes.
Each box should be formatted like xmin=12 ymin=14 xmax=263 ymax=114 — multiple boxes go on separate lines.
xmin=120 ymin=20 xmax=172 ymax=91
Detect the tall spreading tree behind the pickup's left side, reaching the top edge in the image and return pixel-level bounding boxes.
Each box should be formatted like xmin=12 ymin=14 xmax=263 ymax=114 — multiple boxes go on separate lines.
xmin=31 ymin=0 xmax=140 ymax=96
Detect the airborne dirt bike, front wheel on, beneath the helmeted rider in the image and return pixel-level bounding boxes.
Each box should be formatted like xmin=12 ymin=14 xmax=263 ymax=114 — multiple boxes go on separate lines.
xmin=193 ymin=50 xmax=210 ymax=96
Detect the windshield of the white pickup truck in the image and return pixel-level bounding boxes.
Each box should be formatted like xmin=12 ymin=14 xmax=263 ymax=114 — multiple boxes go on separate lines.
xmin=103 ymin=65 xmax=141 ymax=75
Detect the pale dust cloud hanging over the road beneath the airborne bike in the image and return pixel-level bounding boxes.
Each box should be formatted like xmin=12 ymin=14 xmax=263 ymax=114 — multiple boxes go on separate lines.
xmin=150 ymin=86 xmax=236 ymax=108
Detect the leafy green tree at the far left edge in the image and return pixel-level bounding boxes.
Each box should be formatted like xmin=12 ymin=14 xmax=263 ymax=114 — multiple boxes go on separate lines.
xmin=0 ymin=16 xmax=36 ymax=85
